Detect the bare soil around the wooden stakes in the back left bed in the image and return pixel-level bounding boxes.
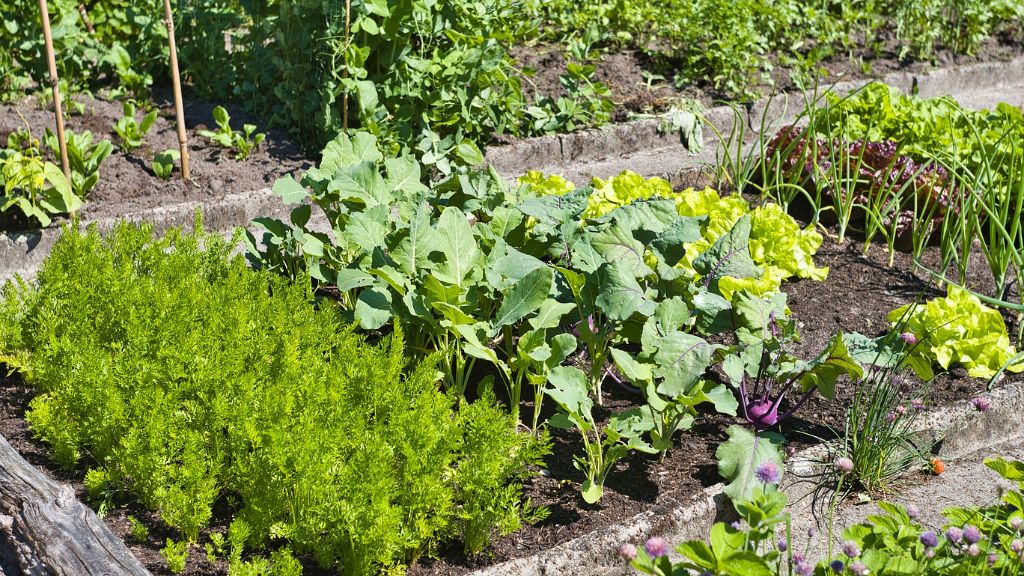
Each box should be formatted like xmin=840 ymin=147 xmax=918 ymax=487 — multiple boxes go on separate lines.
xmin=0 ymin=89 xmax=312 ymax=231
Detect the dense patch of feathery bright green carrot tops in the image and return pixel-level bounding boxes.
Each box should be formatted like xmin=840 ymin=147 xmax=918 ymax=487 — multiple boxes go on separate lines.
xmin=0 ymin=218 xmax=546 ymax=574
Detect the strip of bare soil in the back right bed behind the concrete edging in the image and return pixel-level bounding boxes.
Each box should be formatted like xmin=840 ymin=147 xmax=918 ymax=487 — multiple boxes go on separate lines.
xmin=512 ymin=34 xmax=1024 ymax=122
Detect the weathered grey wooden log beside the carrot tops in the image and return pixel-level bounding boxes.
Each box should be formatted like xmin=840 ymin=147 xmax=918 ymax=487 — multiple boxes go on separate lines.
xmin=0 ymin=436 xmax=150 ymax=576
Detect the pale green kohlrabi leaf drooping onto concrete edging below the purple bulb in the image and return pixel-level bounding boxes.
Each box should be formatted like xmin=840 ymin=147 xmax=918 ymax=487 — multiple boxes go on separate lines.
xmin=715 ymin=425 xmax=785 ymax=502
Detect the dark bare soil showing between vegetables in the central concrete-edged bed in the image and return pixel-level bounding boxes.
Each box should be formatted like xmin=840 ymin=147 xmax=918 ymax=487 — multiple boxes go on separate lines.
xmin=0 ymin=220 xmax=1021 ymax=576
